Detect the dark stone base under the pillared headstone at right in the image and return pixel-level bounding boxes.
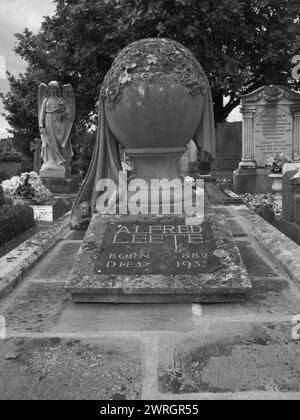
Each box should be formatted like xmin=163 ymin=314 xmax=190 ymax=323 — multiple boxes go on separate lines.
xmin=233 ymin=168 xmax=272 ymax=194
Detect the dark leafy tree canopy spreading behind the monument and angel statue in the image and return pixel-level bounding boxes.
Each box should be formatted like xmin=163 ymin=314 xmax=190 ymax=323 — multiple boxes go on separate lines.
xmin=3 ymin=0 xmax=299 ymax=152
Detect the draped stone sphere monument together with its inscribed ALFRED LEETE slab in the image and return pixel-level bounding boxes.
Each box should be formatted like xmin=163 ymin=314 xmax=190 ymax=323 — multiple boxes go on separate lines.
xmin=68 ymin=39 xmax=251 ymax=303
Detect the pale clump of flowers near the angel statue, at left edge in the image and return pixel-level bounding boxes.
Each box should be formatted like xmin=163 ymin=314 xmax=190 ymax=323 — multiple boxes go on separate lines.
xmin=1 ymin=172 xmax=52 ymax=204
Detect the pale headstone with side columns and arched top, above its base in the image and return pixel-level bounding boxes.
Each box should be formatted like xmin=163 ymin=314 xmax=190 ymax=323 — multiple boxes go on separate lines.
xmin=242 ymin=86 xmax=300 ymax=167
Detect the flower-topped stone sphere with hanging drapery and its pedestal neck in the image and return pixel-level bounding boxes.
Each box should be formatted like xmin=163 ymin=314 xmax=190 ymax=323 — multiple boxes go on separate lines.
xmin=72 ymin=38 xmax=215 ymax=228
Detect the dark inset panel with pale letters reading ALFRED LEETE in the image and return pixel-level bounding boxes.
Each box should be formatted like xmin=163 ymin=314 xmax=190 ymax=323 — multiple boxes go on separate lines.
xmin=95 ymin=222 xmax=221 ymax=275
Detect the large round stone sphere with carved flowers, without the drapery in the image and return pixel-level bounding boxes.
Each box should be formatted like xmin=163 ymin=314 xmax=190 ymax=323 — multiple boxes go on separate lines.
xmin=101 ymin=38 xmax=209 ymax=149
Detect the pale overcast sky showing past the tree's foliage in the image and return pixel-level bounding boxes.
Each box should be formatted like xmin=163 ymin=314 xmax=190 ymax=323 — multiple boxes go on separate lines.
xmin=0 ymin=0 xmax=241 ymax=138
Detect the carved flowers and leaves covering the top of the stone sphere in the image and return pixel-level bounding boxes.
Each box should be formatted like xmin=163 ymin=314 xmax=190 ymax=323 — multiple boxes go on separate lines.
xmin=101 ymin=38 xmax=207 ymax=109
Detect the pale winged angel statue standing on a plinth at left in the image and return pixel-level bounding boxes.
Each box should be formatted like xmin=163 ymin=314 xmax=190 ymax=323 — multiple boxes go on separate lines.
xmin=38 ymin=81 xmax=76 ymax=178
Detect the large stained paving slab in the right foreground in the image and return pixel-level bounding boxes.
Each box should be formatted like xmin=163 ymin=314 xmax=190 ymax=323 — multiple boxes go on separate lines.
xmin=158 ymin=322 xmax=300 ymax=398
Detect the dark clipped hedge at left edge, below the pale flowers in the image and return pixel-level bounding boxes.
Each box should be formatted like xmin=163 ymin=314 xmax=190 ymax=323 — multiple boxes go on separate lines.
xmin=0 ymin=205 xmax=34 ymax=246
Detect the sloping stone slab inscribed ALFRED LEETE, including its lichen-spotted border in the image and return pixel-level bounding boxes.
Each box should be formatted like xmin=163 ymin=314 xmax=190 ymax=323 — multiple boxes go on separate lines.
xmin=68 ymin=215 xmax=251 ymax=303
